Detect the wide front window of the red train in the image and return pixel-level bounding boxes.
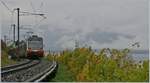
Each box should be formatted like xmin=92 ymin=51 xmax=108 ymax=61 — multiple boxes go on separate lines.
xmin=28 ymin=41 xmax=43 ymax=50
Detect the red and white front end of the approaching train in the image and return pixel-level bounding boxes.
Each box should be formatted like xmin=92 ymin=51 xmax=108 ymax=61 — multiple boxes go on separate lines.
xmin=27 ymin=35 xmax=44 ymax=58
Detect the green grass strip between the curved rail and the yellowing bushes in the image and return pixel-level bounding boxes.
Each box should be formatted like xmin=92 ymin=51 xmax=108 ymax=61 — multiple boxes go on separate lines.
xmin=51 ymin=63 xmax=75 ymax=82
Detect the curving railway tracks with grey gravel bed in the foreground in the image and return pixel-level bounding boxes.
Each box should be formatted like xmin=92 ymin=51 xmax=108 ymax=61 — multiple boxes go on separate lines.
xmin=1 ymin=60 xmax=57 ymax=82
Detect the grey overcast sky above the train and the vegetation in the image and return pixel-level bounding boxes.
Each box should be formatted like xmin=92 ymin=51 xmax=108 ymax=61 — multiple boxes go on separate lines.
xmin=0 ymin=0 xmax=148 ymax=50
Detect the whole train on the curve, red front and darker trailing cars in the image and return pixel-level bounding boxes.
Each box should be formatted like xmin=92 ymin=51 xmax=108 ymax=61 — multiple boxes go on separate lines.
xmin=8 ymin=35 xmax=44 ymax=58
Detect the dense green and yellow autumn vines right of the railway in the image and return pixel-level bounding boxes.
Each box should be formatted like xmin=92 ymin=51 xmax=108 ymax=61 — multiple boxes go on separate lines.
xmin=48 ymin=47 xmax=149 ymax=82
